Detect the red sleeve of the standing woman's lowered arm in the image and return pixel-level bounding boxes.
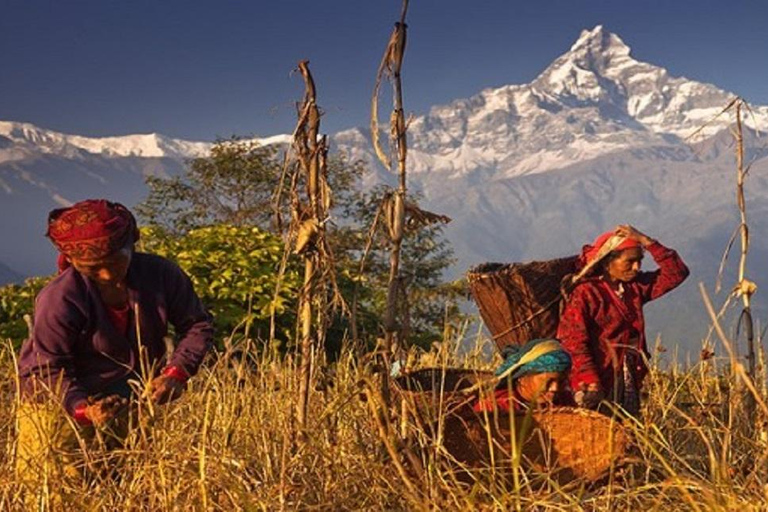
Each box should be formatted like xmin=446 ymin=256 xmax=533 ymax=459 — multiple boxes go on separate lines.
xmin=557 ymin=285 xmax=600 ymax=391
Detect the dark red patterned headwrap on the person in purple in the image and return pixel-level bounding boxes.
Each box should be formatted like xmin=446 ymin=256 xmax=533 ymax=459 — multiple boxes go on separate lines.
xmin=46 ymin=199 xmax=139 ymax=273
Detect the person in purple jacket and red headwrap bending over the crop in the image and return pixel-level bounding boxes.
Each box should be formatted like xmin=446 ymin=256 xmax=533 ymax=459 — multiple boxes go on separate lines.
xmin=17 ymin=200 xmax=213 ymax=498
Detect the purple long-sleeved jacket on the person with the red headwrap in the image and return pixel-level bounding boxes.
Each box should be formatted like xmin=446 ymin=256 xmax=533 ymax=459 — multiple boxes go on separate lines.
xmin=19 ymin=253 xmax=213 ymax=414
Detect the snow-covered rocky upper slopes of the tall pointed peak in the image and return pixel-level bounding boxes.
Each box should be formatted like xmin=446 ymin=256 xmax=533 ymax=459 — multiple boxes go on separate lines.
xmin=336 ymin=26 xmax=768 ymax=183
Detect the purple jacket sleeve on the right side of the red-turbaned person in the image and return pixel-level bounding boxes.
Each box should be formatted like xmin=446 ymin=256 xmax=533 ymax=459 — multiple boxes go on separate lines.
xmin=164 ymin=261 xmax=213 ymax=375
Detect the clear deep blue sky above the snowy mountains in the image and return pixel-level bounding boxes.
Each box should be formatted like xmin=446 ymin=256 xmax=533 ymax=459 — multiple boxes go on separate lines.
xmin=0 ymin=0 xmax=768 ymax=140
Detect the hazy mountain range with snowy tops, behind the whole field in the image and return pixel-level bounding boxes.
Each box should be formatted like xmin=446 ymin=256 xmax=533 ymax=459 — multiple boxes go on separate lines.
xmin=0 ymin=26 xmax=768 ymax=347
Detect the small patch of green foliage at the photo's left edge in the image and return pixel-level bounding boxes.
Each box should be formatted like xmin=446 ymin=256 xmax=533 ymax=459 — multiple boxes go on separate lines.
xmin=0 ymin=276 xmax=53 ymax=347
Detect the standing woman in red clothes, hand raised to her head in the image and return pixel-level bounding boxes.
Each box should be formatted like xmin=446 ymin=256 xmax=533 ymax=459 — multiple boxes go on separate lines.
xmin=557 ymin=225 xmax=688 ymax=415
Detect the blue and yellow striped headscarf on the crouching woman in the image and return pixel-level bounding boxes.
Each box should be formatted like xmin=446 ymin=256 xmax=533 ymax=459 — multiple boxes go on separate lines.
xmin=495 ymin=338 xmax=571 ymax=379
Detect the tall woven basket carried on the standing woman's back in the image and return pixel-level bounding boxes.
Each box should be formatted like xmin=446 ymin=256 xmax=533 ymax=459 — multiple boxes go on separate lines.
xmin=467 ymin=256 xmax=578 ymax=350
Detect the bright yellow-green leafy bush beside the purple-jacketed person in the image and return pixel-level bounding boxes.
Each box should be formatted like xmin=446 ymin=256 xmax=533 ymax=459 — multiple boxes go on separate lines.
xmin=141 ymin=225 xmax=300 ymax=338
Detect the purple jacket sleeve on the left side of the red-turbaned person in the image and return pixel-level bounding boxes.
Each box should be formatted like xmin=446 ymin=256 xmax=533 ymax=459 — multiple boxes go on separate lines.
xmin=19 ymin=293 xmax=88 ymax=414
